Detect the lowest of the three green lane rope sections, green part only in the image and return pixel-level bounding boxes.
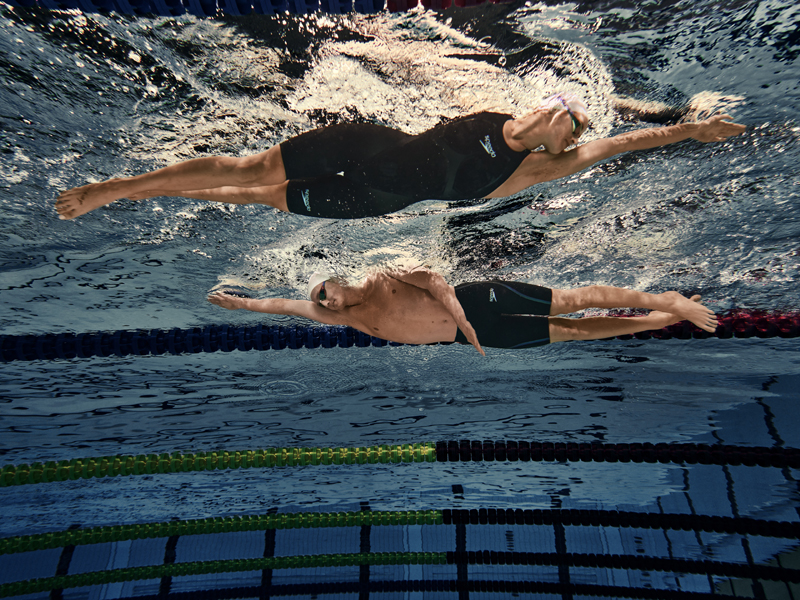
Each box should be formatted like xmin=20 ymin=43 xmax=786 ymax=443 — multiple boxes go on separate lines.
xmin=0 ymin=552 xmax=447 ymax=598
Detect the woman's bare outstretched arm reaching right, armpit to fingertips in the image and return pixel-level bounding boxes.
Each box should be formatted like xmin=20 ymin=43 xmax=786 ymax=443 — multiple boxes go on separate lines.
xmin=492 ymin=114 xmax=747 ymax=197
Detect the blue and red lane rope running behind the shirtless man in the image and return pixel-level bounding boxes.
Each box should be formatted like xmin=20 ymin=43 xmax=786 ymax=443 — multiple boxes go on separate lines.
xmin=0 ymin=311 xmax=800 ymax=362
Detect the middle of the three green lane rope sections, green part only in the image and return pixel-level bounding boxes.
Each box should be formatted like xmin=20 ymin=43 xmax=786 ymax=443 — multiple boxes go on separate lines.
xmin=0 ymin=510 xmax=443 ymax=555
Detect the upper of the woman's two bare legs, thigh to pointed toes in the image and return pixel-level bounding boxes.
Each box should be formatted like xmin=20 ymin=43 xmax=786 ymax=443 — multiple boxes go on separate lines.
xmin=56 ymin=146 xmax=286 ymax=219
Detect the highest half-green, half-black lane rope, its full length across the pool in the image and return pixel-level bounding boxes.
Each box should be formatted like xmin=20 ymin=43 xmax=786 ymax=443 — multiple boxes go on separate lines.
xmin=0 ymin=440 xmax=800 ymax=487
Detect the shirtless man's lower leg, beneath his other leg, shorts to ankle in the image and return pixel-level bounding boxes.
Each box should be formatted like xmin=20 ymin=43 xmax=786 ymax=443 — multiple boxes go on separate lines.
xmin=549 ymin=304 xmax=688 ymax=343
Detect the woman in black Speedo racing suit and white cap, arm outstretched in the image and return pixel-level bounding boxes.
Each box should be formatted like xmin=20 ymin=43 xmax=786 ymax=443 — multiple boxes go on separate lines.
xmin=56 ymin=94 xmax=745 ymax=219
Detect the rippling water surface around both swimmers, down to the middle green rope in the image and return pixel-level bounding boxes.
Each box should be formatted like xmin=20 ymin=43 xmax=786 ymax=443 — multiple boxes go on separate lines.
xmin=0 ymin=1 xmax=800 ymax=535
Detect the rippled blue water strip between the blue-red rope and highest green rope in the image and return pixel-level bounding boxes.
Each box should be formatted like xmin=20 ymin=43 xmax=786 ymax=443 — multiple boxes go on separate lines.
xmin=0 ymin=340 xmax=797 ymax=463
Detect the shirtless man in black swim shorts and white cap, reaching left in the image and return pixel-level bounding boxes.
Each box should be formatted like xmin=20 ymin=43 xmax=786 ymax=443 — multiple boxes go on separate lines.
xmin=208 ymin=267 xmax=717 ymax=356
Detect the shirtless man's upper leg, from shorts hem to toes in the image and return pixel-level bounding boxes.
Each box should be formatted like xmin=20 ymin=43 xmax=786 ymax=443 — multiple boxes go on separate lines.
xmin=550 ymin=285 xmax=717 ymax=335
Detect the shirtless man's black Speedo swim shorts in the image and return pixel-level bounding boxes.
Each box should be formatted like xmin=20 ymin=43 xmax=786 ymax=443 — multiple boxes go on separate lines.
xmin=455 ymin=281 xmax=553 ymax=348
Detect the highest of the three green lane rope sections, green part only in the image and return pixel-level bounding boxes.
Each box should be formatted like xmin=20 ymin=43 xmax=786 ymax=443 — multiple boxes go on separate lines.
xmin=0 ymin=442 xmax=436 ymax=487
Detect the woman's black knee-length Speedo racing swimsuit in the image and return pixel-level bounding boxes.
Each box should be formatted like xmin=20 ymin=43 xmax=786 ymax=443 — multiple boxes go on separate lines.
xmin=281 ymin=112 xmax=528 ymax=219
